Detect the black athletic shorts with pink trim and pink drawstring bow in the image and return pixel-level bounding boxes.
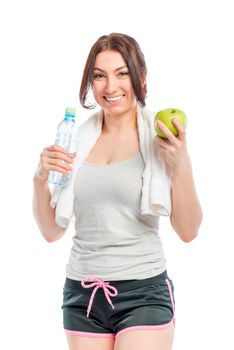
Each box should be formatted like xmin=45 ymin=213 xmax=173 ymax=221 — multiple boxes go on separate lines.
xmin=62 ymin=271 xmax=175 ymax=337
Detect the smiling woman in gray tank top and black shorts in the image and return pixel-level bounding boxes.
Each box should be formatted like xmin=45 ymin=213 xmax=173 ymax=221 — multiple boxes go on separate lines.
xmin=33 ymin=33 xmax=202 ymax=350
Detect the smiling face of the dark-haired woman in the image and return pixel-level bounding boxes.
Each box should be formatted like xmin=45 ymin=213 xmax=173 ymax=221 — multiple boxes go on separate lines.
xmin=92 ymin=50 xmax=136 ymax=114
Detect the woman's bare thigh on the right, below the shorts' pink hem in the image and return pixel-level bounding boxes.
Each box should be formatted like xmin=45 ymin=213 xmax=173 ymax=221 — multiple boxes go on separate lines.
xmin=114 ymin=326 xmax=174 ymax=350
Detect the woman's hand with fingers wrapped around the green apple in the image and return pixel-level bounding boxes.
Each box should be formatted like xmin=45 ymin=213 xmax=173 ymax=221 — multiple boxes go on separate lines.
xmin=156 ymin=118 xmax=190 ymax=175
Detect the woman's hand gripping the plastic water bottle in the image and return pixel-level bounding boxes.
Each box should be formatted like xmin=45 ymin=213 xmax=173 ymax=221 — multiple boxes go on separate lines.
xmin=35 ymin=145 xmax=75 ymax=181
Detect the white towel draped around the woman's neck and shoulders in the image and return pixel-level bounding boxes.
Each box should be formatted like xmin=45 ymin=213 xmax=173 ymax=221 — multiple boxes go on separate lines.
xmin=50 ymin=106 xmax=171 ymax=228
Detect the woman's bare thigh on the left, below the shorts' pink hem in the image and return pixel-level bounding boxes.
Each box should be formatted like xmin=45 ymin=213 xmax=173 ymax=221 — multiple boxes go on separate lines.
xmin=66 ymin=334 xmax=115 ymax=350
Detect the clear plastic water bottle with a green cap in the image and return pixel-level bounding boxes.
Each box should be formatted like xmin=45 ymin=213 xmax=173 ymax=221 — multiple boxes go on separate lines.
xmin=48 ymin=107 xmax=76 ymax=187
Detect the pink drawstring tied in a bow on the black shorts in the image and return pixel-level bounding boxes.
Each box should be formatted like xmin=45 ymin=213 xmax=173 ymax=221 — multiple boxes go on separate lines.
xmin=81 ymin=277 xmax=118 ymax=317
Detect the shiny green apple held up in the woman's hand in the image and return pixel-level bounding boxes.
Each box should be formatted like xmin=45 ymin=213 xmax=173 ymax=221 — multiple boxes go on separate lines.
xmin=154 ymin=108 xmax=187 ymax=139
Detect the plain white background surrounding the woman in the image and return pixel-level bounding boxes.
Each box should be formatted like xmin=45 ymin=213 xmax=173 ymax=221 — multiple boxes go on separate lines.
xmin=0 ymin=0 xmax=234 ymax=350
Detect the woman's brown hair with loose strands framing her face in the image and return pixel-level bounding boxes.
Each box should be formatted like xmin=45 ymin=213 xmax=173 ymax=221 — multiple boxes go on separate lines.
xmin=80 ymin=33 xmax=147 ymax=109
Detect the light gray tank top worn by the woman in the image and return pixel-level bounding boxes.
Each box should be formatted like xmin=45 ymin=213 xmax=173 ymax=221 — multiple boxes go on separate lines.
xmin=66 ymin=152 xmax=166 ymax=281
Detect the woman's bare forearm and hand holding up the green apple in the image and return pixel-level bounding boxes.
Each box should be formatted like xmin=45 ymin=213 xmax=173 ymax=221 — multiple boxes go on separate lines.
xmin=157 ymin=118 xmax=202 ymax=242
